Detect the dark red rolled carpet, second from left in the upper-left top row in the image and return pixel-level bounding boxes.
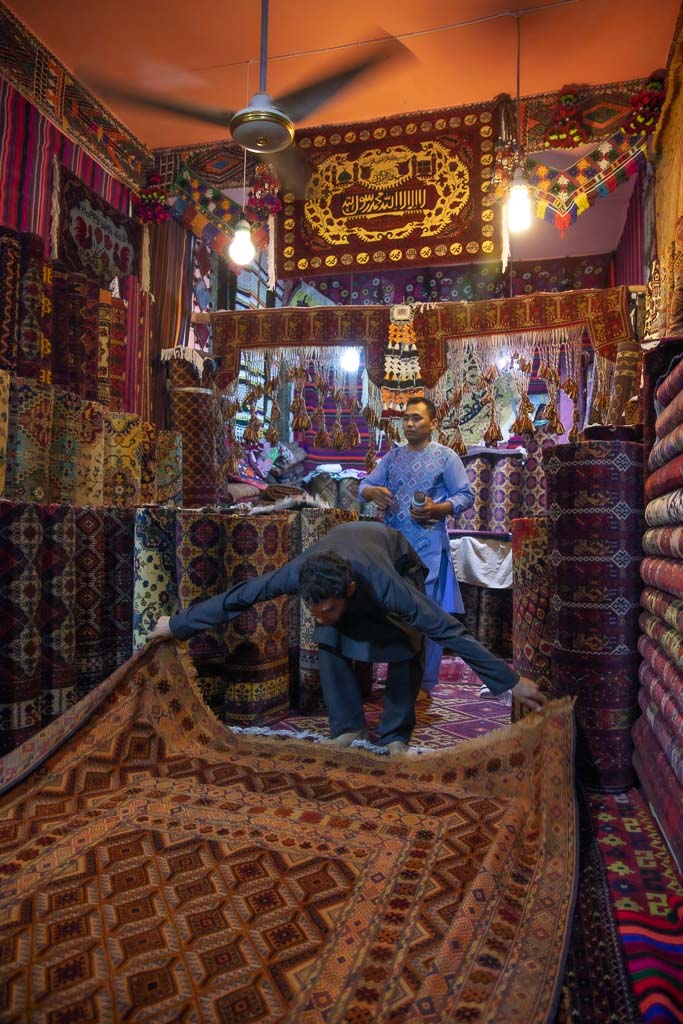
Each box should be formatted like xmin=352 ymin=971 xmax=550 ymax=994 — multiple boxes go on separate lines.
xmin=15 ymin=234 xmax=52 ymax=384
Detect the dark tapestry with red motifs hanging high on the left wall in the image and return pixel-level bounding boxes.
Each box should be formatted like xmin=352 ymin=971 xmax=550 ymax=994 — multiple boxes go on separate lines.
xmin=58 ymin=166 xmax=140 ymax=285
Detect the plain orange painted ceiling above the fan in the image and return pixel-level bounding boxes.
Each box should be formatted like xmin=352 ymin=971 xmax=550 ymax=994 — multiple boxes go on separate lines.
xmin=8 ymin=0 xmax=680 ymax=147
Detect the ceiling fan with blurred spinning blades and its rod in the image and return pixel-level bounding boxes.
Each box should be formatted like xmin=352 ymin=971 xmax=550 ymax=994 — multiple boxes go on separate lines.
xmin=82 ymin=0 xmax=410 ymax=196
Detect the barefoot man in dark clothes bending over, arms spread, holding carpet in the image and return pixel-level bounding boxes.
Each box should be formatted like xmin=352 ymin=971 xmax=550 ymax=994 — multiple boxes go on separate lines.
xmin=151 ymin=522 xmax=546 ymax=754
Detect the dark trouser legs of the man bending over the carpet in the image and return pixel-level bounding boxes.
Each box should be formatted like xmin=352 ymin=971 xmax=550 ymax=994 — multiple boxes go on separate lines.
xmin=318 ymin=647 xmax=424 ymax=745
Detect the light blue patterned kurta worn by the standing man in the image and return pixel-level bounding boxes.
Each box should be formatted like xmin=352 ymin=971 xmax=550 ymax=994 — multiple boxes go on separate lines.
xmin=358 ymin=441 xmax=474 ymax=612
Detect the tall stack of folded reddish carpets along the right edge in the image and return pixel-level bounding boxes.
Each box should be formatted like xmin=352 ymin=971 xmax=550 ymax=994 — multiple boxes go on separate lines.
xmin=633 ymin=356 xmax=683 ymax=863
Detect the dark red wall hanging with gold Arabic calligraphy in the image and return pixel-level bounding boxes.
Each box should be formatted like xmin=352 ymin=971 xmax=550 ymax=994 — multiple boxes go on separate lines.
xmin=276 ymin=103 xmax=501 ymax=279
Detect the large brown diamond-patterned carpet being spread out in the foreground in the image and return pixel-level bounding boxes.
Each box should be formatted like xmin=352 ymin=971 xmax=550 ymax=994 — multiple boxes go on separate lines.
xmin=0 ymin=644 xmax=578 ymax=1024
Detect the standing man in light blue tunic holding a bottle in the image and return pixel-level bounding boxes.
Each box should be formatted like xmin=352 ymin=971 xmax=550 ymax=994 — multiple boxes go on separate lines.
xmin=358 ymin=398 xmax=474 ymax=693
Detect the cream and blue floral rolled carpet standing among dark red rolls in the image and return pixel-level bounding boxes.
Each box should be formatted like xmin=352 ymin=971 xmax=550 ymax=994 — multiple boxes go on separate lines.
xmin=133 ymin=508 xmax=178 ymax=650
